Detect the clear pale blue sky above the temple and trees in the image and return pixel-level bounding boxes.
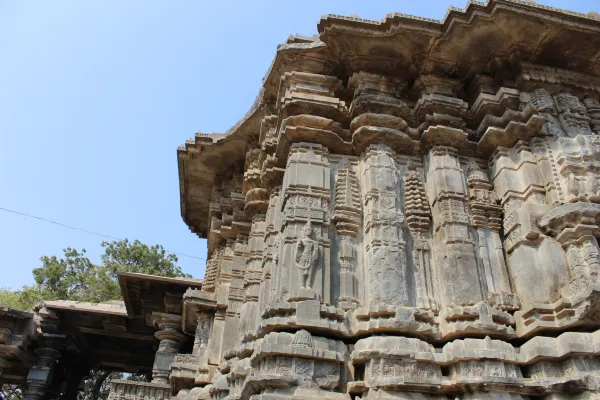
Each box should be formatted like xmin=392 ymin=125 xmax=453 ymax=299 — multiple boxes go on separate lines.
xmin=0 ymin=0 xmax=600 ymax=288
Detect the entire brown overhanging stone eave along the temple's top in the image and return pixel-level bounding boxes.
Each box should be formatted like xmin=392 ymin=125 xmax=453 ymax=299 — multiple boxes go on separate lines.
xmin=178 ymin=0 xmax=600 ymax=237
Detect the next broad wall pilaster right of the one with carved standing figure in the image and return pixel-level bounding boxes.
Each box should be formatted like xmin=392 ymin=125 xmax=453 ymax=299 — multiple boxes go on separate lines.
xmin=363 ymin=144 xmax=413 ymax=306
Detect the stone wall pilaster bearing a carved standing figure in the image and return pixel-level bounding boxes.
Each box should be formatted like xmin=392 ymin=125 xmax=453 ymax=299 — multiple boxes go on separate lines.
xmin=275 ymin=143 xmax=331 ymax=304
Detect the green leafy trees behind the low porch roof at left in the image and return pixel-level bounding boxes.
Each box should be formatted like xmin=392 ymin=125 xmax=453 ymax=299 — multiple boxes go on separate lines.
xmin=0 ymin=239 xmax=191 ymax=399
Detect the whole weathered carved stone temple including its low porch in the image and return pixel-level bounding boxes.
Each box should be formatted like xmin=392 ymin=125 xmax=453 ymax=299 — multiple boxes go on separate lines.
xmin=5 ymin=0 xmax=600 ymax=400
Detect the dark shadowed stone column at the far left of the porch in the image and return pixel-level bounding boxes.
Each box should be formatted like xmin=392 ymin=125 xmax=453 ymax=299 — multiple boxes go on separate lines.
xmin=25 ymin=333 xmax=65 ymax=400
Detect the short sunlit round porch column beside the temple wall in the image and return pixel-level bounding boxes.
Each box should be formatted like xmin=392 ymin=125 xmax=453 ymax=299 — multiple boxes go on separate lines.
xmin=152 ymin=312 xmax=185 ymax=384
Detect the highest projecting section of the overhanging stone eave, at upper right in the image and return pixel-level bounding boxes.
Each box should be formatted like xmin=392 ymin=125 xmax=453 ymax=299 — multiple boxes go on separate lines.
xmin=318 ymin=0 xmax=600 ymax=79
